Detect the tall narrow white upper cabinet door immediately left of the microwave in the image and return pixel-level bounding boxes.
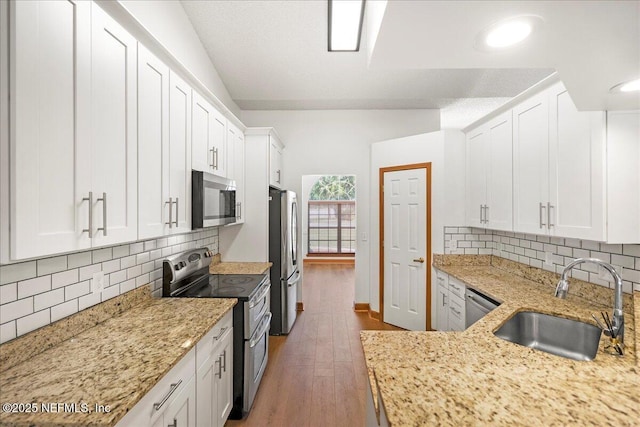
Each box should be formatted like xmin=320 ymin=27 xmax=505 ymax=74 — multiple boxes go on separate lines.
xmin=165 ymin=72 xmax=192 ymax=233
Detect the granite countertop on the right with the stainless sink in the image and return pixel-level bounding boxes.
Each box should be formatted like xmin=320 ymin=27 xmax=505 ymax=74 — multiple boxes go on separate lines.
xmin=361 ymin=256 xmax=640 ymax=426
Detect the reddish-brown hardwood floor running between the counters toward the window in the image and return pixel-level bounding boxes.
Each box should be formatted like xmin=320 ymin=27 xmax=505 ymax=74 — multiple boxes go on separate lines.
xmin=225 ymin=265 xmax=399 ymax=427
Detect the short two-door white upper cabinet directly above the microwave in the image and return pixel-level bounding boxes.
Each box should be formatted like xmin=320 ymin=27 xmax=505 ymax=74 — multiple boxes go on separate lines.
xmin=191 ymin=91 xmax=227 ymax=177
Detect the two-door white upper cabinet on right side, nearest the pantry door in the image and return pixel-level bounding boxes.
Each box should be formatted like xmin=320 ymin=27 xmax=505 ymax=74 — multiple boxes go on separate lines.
xmin=466 ymin=111 xmax=513 ymax=231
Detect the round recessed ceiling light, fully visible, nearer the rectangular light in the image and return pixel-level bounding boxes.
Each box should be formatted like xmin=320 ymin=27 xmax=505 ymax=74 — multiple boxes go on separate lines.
xmin=475 ymin=15 xmax=543 ymax=52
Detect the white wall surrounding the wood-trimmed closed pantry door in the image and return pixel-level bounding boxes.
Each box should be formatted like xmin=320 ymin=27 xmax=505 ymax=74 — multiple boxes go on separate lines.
xmin=368 ymin=130 xmax=465 ymax=325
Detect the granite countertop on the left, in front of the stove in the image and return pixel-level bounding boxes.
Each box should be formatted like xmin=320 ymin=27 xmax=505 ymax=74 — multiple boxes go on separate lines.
xmin=0 ymin=296 xmax=237 ymax=426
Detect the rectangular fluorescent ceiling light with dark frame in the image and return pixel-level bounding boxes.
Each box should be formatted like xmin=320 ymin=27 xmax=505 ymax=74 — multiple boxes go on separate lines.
xmin=329 ymin=0 xmax=365 ymax=52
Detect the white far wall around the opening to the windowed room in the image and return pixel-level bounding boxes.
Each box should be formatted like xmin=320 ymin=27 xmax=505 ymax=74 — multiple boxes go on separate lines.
xmin=241 ymin=110 xmax=440 ymax=302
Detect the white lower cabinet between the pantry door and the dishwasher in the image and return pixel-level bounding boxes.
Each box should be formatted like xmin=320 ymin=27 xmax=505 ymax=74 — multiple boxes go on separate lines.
xmin=436 ymin=271 xmax=466 ymax=331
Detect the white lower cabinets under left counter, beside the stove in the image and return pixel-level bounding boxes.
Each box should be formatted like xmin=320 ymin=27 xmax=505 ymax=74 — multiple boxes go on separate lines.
xmin=117 ymin=311 xmax=233 ymax=427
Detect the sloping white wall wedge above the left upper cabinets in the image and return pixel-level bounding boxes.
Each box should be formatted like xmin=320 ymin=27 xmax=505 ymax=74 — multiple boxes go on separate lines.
xmin=118 ymin=0 xmax=240 ymax=117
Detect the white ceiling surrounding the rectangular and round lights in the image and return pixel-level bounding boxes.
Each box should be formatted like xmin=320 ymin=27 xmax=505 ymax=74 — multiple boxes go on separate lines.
xmin=181 ymin=0 xmax=640 ymax=127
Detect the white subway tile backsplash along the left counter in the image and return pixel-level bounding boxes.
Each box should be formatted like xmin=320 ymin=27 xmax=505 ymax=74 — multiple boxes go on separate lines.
xmin=0 ymin=227 xmax=220 ymax=342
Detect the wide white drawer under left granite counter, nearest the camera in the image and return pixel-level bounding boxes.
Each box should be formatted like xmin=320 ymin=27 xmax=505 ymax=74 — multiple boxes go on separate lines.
xmin=116 ymin=349 xmax=196 ymax=427
